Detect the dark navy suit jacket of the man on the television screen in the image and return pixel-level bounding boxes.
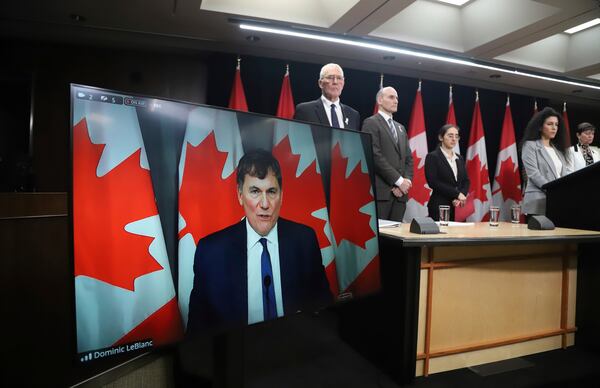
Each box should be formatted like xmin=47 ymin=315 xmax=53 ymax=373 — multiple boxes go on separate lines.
xmin=187 ymin=218 xmax=332 ymax=335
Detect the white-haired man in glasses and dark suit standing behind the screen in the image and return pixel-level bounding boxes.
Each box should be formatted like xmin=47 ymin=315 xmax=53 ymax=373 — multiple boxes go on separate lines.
xmin=294 ymin=63 xmax=360 ymax=130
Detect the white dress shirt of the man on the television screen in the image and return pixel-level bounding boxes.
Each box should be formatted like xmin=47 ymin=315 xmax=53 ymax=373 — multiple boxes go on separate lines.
xmin=246 ymin=218 xmax=283 ymax=325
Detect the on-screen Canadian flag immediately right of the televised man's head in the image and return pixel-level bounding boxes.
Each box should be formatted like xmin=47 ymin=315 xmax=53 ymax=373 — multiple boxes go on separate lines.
xmin=272 ymin=120 xmax=339 ymax=296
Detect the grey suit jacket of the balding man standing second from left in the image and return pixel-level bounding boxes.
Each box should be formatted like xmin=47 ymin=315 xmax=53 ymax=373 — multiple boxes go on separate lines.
xmin=362 ymin=113 xmax=413 ymax=202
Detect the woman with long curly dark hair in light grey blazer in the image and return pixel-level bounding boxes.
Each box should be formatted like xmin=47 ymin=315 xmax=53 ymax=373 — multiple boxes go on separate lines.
xmin=521 ymin=107 xmax=571 ymax=215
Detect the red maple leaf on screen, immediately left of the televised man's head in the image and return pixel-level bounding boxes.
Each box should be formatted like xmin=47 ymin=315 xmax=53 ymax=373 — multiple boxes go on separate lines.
xmin=179 ymin=132 xmax=244 ymax=244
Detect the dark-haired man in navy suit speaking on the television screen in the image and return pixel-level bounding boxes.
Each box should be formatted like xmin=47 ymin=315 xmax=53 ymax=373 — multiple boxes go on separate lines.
xmin=187 ymin=150 xmax=332 ymax=334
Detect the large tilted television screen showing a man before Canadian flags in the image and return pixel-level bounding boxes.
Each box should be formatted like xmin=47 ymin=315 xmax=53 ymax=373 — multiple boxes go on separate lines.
xmin=71 ymin=84 xmax=380 ymax=363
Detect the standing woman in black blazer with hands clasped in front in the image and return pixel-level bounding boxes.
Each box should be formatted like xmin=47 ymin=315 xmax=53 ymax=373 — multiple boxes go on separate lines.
xmin=425 ymin=124 xmax=470 ymax=221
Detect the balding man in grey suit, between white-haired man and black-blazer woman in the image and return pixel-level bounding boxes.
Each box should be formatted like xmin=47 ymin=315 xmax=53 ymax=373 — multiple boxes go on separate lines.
xmin=362 ymin=86 xmax=413 ymax=221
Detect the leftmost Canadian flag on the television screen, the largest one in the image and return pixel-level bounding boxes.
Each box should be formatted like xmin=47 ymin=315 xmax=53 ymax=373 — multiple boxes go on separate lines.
xmin=73 ymin=99 xmax=183 ymax=353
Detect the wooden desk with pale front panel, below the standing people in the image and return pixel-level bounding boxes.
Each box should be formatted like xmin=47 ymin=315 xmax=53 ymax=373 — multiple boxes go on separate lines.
xmin=379 ymin=222 xmax=600 ymax=381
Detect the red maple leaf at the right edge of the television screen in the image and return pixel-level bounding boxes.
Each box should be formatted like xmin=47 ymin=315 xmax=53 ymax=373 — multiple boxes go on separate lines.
xmin=330 ymin=144 xmax=375 ymax=249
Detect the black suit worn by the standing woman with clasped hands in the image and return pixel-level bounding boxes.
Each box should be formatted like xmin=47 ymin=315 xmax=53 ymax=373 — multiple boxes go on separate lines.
xmin=425 ymin=147 xmax=471 ymax=221
